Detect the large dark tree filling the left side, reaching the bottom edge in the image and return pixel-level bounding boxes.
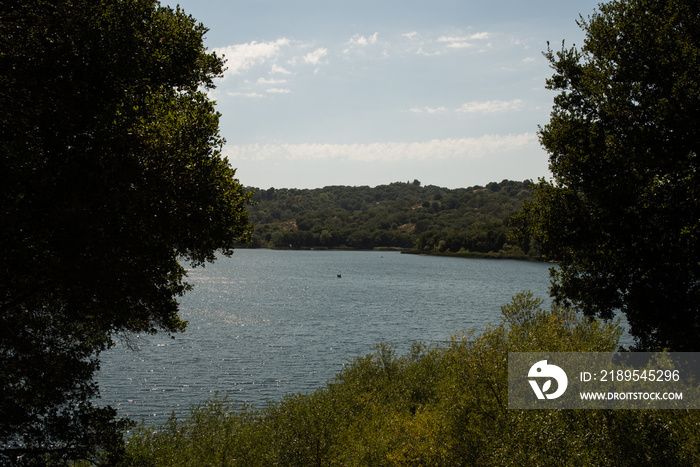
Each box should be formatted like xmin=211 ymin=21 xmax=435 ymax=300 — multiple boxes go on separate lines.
xmin=0 ymin=0 xmax=251 ymax=463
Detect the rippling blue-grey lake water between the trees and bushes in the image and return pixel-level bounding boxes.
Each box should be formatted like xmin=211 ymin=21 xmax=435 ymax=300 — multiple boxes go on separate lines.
xmin=98 ymin=249 xmax=550 ymax=423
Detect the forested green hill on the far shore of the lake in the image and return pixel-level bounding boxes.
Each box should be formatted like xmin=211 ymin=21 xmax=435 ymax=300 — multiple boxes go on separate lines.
xmin=243 ymin=180 xmax=531 ymax=256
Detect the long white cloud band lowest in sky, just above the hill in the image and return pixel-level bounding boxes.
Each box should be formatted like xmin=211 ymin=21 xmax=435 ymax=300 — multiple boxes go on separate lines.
xmin=224 ymin=133 xmax=538 ymax=162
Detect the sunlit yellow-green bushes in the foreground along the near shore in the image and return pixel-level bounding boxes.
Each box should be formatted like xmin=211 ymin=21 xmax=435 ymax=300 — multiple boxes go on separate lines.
xmin=117 ymin=293 xmax=700 ymax=466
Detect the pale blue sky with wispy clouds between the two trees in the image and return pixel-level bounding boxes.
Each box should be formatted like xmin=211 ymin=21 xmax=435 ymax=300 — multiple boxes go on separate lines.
xmin=161 ymin=0 xmax=598 ymax=189
